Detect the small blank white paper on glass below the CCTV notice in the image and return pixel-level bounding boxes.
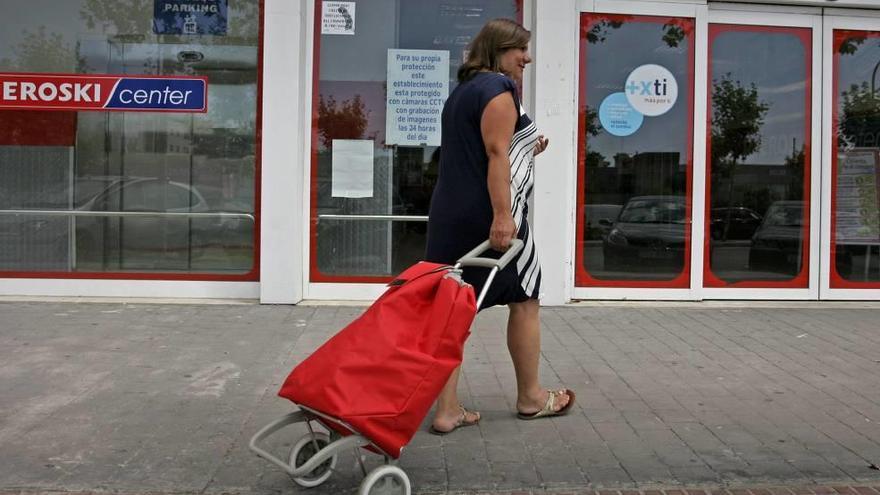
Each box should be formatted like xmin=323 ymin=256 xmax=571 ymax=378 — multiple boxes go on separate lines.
xmin=330 ymin=139 xmax=375 ymax=198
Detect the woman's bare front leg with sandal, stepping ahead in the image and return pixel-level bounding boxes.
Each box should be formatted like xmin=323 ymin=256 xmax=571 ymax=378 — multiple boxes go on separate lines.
xmin=507 ymin=299 xmax=569 ymax=414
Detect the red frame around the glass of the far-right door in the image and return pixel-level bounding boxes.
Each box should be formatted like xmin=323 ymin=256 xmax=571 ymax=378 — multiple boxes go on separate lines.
xmin=828 ymin=29 xmax=880 ymax=289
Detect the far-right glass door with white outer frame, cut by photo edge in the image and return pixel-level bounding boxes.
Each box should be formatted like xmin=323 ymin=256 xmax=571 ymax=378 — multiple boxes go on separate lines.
xmin=822 ymin=12 xmax=880 ymax=299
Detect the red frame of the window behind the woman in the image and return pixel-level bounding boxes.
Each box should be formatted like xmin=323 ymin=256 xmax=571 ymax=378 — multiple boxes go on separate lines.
xmin=309 ymin=0 xmax=534 ymax=284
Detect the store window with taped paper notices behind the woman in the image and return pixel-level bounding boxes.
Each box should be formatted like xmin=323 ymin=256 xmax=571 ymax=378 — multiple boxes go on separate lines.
xmin=310 ymin=0 xmax=522 ymax=282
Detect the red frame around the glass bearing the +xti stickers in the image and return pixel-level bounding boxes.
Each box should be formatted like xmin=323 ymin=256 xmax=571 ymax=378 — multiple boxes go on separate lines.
xmin=575 ymin=13 xmax=696 ymax=288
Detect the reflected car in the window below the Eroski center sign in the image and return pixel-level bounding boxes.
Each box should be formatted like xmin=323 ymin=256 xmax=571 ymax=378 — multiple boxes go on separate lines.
xmin=0 ymin=176 xmax=254 ymax=270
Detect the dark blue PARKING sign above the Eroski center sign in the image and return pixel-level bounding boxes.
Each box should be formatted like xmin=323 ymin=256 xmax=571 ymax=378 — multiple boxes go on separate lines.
xmin=153 ymin=0 xmax=228 ymax=36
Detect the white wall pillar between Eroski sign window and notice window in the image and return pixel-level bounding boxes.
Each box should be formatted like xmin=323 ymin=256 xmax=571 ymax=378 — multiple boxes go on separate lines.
xmin=260 ymin=0 xmax=313 ymax=304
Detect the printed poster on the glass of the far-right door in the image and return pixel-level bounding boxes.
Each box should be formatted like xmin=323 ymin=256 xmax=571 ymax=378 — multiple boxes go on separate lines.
xmin=835 ymin=149 xmax=880 ymax=244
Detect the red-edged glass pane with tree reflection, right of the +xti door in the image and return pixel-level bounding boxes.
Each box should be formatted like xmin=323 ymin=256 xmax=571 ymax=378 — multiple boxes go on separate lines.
xmin=705 ymin=25 xmax=810 ymax=287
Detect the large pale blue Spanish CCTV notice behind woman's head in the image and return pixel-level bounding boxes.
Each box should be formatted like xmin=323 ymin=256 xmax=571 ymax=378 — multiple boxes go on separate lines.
xmin=385 ymin=49 xmax=449 ymax=146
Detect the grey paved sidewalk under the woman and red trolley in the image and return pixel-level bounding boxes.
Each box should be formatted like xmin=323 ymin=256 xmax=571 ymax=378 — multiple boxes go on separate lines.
xmin=0 ymin=300 xmax=880 ymax=495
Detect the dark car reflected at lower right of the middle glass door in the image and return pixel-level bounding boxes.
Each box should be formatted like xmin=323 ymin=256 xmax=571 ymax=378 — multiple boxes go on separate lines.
xmin=749 ymin=201 xmax=804 ymax=275
